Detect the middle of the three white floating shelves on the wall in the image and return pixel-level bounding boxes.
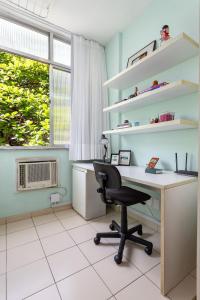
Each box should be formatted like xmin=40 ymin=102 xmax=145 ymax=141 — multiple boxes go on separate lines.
xmin=103 ymin=80 xmax=199 ymax=112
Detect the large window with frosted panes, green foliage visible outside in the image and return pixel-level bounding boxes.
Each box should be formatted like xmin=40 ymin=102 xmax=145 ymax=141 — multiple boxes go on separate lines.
xmin=0 ymin=18 xmax=71 ymax=146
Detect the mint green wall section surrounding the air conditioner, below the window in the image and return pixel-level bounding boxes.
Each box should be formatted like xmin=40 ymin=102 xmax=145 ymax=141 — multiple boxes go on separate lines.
xmin=0 ymin=149 xmax=71 ymax=218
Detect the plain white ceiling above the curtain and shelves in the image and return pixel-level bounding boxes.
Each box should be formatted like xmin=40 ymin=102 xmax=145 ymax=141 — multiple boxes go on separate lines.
xmin=46 ymin=0 xmax=152 ymax=45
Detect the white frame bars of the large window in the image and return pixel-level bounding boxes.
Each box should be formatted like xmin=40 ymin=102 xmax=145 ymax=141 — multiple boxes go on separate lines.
xmin=0 ymin=14 xmax=71 ymax=150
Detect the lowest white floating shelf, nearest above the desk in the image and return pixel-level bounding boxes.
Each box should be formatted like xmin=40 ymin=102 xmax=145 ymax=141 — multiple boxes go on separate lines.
xmin=103 ymin=119 xmax=198 ymax=135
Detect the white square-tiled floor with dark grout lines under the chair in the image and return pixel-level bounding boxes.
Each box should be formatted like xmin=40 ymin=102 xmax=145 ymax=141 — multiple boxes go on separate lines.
xmin=0 ymin=210 xmax=196 ymax=300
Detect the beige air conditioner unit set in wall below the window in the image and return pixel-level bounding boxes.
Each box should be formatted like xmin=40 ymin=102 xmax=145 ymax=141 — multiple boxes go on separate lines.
xmin=17 ymin=158 xmax=58 ymax=191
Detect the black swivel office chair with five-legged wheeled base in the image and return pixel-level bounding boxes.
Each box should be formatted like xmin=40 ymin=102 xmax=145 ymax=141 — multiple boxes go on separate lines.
xmin=93 ymin=162 xmax=153 ymax=264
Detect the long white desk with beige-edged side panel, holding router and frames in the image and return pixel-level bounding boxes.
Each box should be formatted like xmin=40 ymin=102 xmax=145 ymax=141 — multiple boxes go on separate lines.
xmin=74 ymin=163 xmax=198 ymax=295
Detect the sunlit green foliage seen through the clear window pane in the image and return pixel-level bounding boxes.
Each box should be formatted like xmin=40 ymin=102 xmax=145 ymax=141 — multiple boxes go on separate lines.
xmin=0 ymin=52 xmax=50 ymax=146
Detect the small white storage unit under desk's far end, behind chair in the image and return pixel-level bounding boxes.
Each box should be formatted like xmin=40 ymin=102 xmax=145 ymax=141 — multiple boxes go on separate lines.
xmin=72 ymin=164 xmax=106 ymax=220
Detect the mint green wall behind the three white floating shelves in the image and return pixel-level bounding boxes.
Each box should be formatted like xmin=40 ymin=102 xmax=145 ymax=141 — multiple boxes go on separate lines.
xmin=106 ymin=0 xmax=199 ymax=219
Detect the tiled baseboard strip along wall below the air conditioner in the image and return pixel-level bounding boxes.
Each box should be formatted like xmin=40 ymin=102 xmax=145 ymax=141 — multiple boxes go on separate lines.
xmin=0 ymin=203 xmax=72 ymax=225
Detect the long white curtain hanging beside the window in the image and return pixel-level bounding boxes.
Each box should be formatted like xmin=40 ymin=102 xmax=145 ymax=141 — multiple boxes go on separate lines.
xmin=70 ymin=36 xmax=107 ymax=160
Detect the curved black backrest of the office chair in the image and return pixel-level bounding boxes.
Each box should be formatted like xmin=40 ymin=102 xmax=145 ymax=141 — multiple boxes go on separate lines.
xmin=93 ymin=162 xmax=122 ymax=188
